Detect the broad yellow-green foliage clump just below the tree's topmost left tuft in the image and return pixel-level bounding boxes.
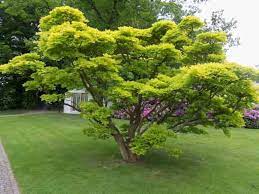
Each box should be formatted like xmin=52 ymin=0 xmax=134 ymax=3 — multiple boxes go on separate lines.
xmin=39 ymin=21 xmax=115 ymax=60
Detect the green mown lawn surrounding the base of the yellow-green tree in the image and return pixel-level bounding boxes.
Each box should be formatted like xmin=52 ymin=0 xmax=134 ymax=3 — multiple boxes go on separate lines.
xmin=0 ymin=113 xmax=259 ymax=194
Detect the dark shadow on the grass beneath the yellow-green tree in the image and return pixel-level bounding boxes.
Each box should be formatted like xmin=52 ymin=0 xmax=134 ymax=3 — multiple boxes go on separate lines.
xmin=33 ymin=135 xmax=206 ymax=175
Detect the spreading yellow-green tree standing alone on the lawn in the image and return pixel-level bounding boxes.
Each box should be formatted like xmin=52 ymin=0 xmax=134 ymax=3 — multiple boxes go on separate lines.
xmin=0 ymin=6 xmax=256 ymax=162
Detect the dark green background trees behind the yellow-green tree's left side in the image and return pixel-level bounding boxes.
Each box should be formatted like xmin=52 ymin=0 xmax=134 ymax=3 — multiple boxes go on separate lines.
xmin=0 ymin=0 xmax=183 ymax=110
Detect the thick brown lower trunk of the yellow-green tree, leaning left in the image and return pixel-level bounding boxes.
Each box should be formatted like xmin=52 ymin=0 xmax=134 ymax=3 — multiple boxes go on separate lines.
xmin=114 ymin=134 xmax=138 ymax=163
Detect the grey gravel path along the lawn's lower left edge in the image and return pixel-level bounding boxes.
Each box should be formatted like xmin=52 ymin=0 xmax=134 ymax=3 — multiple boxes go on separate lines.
xmin=0 ymin=142 xmax=20 ymax=194
